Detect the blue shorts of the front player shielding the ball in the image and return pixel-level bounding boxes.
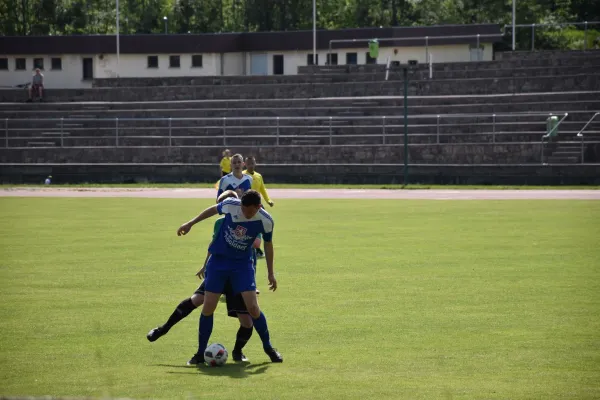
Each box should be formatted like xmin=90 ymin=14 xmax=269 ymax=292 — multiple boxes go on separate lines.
xmin=204 ymin=255 xmax=256 ymax=293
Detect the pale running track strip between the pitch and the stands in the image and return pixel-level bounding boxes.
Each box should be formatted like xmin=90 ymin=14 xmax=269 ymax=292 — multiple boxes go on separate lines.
xmin=0 ymin=188 xmax=600 ymax=200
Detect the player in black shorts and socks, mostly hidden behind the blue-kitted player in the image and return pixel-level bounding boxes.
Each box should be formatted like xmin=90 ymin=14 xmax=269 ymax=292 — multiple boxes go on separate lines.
xmin=146 ymin=190 xmax=253 ymax=365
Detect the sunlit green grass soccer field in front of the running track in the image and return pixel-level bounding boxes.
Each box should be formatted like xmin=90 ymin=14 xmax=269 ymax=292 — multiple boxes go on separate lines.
xmin=0 ymin=198 xmax=600 ymax=399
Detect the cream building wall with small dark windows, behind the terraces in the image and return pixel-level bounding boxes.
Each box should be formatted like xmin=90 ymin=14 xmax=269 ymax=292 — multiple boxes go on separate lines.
xmin=0 ymin=43 xmax=494 ymax=89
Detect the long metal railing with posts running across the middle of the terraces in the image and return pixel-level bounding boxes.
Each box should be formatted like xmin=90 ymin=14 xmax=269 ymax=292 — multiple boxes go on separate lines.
xmin=5 ymin=112 xmax=568 ymax=148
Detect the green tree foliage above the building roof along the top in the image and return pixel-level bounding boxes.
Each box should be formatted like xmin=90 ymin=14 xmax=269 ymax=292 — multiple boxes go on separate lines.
xmin=0 ymin=0 xmax=600 ymax=54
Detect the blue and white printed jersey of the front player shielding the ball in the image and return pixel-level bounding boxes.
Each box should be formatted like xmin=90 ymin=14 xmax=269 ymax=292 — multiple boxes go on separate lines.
xmin=208 ymin=198 xmax=273 ymax=263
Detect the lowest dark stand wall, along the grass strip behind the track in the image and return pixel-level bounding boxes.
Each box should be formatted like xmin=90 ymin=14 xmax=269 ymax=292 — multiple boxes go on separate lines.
xmin=0 ymin=163 xmax=600 ymax=187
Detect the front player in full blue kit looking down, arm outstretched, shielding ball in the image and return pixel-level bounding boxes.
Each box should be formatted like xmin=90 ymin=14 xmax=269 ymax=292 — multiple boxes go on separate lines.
xmin=177 ymin=190 xmax=283 ymax=362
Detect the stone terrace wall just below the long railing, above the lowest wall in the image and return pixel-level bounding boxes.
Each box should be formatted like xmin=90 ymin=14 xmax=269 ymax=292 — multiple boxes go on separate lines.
xmin=0 ymin=142 xmax=542 ymax=166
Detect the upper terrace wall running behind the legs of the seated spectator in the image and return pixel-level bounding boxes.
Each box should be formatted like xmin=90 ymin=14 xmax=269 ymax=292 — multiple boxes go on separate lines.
xmin=0 ymin=74 xmax=600 ymax=102
